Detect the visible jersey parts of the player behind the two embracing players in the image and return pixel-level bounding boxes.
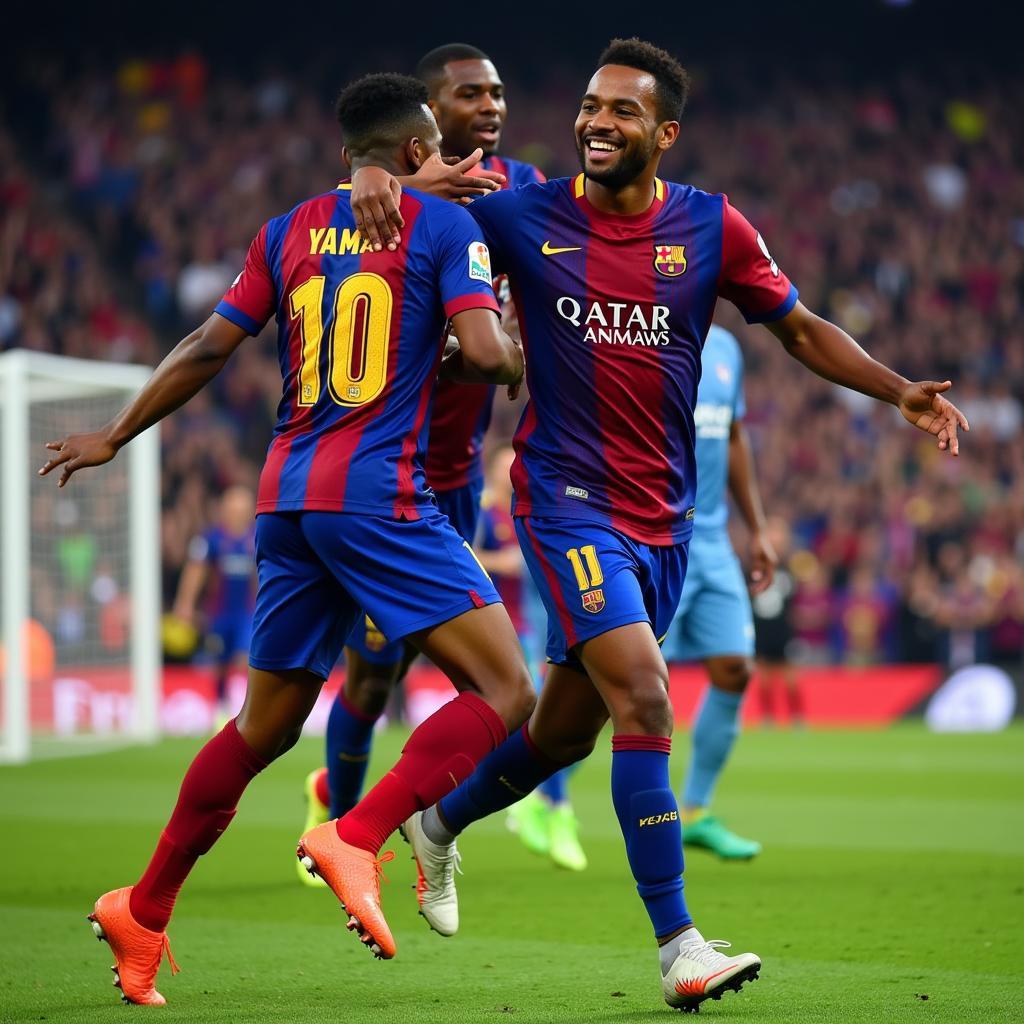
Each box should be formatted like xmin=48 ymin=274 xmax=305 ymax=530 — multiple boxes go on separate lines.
xmin=427 ymin=157 xmax=547 ymax=490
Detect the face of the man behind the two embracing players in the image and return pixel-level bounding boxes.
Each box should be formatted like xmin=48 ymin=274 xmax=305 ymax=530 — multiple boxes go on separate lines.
xmin=430 ymin=60 xmax=508 ymax=157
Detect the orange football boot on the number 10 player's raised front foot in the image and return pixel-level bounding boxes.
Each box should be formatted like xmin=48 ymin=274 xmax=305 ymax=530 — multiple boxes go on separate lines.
xmin=296 ymin=821 xmax=395 ymax=959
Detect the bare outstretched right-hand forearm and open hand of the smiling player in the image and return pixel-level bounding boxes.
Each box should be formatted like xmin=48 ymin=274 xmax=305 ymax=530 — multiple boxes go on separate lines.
xmin=766 ymin=302 xmax=971 ymax=455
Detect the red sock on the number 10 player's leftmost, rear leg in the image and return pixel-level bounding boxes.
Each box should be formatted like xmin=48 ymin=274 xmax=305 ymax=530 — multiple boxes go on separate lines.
xmin=128 ymin=719 xmax=266 ymax=932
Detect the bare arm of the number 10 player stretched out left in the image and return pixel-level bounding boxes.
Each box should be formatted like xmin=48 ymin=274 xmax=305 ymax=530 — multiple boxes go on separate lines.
xmin=39 ymin=313 xmax=247 ymax=487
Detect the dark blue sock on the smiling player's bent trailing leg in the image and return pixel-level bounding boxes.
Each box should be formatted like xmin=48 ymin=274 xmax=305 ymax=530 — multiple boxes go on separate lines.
xmin=438 ymin=725 xmax=564 ymax=836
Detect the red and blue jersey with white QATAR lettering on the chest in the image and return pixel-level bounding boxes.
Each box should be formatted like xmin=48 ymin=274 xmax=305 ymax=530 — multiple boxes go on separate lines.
xmin=468 ymin=175 xmax=797 ymax=545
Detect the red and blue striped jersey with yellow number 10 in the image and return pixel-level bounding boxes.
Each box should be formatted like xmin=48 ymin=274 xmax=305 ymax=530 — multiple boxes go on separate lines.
xmin=216 ymin=184 xmax=498 ymax=519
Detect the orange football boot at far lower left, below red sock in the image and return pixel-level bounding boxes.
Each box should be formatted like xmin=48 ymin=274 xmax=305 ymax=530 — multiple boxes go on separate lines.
xmin=88 ymin=886 xmax=178 ymax=1007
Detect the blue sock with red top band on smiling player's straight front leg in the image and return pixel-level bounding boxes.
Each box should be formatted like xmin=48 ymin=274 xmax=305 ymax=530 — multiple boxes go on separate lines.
xmin=611 ymin=735 xmax=693 ymax=938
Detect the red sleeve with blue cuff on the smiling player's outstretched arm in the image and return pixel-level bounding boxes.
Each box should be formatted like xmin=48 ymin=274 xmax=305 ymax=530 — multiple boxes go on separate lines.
xmin=718 ymin=197 xmax=800 ymax=324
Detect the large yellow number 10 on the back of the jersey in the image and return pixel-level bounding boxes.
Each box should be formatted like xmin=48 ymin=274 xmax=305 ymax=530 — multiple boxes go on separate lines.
xmin=289 ymin=273 xmax=393 ymax=406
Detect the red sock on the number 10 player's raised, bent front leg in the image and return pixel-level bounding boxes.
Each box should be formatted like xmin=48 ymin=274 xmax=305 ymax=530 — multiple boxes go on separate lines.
xmin=337 ymin=692 xmax=508 ymax=853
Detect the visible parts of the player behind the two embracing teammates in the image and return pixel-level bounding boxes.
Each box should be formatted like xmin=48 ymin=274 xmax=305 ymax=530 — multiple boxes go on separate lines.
xmin=299 ymin=43 xmax=545 ymax=864
